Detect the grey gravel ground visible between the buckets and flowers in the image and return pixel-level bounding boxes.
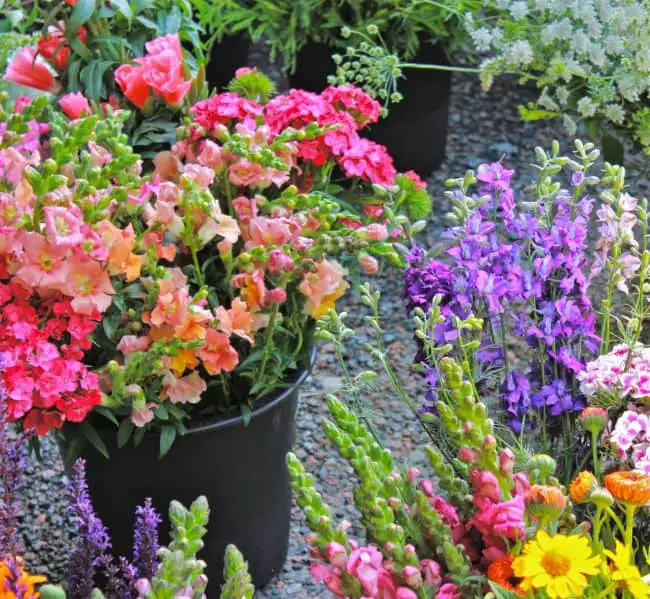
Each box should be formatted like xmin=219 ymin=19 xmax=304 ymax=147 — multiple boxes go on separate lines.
xmin=15 ymin=48 xmax=648 ymax=599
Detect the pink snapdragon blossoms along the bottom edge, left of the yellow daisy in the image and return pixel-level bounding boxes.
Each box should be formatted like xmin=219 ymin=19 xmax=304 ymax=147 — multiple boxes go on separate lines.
xmin=311 ymin=541 xmax=460 ymax=599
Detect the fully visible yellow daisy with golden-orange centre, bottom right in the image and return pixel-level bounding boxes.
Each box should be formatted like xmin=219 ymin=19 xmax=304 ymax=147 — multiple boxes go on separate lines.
xmin=512 ymin=530 xmax=601 ymax=599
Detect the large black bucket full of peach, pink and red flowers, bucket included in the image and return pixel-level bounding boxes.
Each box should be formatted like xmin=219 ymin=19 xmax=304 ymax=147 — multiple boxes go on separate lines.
xmin=0 ymin=69 xmax=430 ymax=585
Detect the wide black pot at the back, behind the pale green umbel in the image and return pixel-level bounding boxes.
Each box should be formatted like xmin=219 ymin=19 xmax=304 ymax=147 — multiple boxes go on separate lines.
xmin=289 ymin=42 xmax=451 ymax=177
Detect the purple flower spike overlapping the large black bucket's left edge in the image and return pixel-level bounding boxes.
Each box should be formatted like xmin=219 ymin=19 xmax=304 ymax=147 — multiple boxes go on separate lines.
xmin=66 ymin=458 xmax=111 ymax=599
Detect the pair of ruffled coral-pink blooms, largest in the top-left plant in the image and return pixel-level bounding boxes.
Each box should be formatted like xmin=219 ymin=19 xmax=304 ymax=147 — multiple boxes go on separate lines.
xmin=115 ymin=34 xmax=192 ymax=109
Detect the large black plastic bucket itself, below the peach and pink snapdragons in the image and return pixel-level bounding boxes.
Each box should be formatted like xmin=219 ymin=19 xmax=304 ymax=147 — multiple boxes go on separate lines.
xmin=62 ymin=358 xmax=309 ymax=597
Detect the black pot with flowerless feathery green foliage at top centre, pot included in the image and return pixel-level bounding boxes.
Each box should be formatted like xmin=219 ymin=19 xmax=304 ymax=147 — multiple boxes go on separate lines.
xmin=210 ymin=0 xmax=479 ymax=176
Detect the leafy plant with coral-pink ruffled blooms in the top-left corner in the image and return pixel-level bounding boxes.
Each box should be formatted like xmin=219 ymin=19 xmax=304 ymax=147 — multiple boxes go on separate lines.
xmin=3 ymin=0 xmax=202 ymax=158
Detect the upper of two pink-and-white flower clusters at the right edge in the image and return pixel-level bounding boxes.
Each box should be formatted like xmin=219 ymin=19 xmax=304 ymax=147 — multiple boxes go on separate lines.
xmin=578 ymin=345 xmax=650 ymax=399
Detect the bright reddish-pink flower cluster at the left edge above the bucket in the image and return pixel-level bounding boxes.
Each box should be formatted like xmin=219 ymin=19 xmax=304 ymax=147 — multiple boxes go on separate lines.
xmin=0 ymin=279 xmax=101 ymax=435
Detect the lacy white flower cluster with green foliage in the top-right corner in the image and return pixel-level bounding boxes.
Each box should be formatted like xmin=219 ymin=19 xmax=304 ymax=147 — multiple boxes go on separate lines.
xmin=466 ymin=0 xmax=650 ymax=150
